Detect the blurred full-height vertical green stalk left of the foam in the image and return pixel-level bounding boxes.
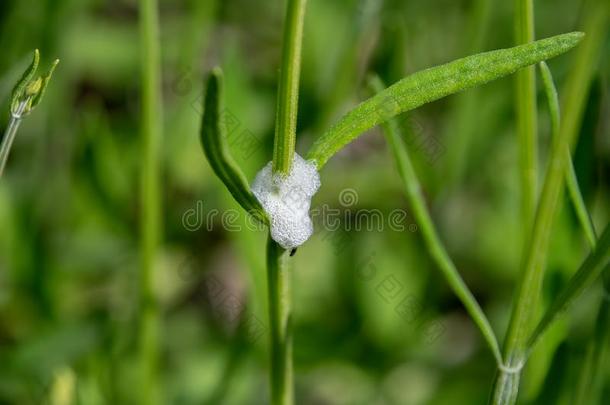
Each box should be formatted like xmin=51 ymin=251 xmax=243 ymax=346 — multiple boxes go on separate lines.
xmin=138 ymin=0 xmax=162 ymax=404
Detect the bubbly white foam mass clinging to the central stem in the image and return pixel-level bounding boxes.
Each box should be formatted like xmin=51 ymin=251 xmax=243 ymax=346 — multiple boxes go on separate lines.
xmin=252 ymin=153 xmax=320 ymax=249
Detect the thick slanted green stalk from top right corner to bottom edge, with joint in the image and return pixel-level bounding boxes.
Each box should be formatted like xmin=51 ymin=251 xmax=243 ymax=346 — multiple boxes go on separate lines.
xmin=491 ymin=1 xmax=609 ymax=405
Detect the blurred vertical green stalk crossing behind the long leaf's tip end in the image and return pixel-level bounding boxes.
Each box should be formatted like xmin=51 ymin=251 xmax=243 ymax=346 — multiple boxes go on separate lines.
xmin=514 ymin=0 xmax=538 ymax=230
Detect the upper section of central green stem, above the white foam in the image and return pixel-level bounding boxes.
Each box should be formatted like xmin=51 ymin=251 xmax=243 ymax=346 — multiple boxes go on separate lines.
xmin=273 ymin=0 xmax=307 ymax=174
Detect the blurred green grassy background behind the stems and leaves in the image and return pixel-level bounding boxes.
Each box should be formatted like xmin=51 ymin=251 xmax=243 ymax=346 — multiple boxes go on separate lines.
xmin=0 ymin=0 xmax=610 ymax=405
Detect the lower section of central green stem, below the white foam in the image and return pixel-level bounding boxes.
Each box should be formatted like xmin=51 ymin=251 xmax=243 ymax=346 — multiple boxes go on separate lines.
xmin=267 ymin=237 xmax=294 ymax=405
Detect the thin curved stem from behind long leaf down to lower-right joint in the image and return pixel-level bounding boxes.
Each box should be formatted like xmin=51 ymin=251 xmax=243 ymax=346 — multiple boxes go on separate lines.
xmin=369 ymin=77 xmax=502 ymax=364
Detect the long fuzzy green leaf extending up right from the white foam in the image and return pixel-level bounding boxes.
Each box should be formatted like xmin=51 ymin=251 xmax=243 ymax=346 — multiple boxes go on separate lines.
xmin=307 ymin=32 xmax=584 ymax=169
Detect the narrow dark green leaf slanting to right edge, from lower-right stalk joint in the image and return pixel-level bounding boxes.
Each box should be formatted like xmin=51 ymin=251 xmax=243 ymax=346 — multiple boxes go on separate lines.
xmin=526 ymin=221 xmax=610 ymax=353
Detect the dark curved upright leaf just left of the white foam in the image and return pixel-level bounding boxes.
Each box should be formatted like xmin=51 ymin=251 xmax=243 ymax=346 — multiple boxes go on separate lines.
xmin=201 ymin=68 xmax=268 ymax=223
